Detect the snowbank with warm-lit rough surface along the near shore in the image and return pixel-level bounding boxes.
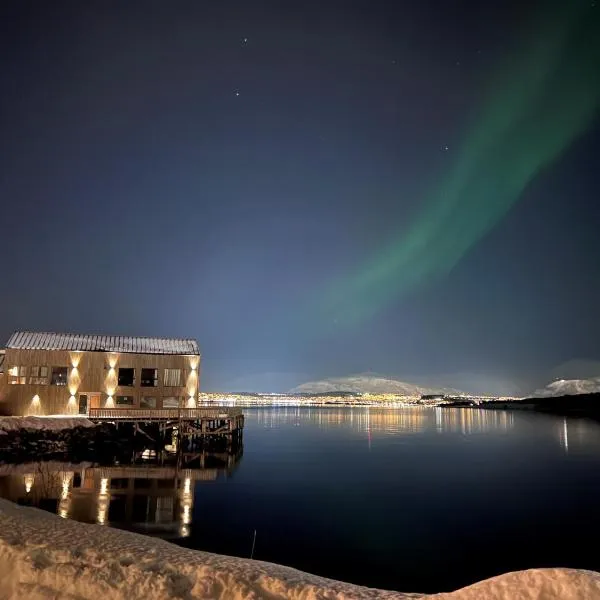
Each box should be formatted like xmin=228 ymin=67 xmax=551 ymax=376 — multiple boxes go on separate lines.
xmin=0 ymin=500 xmax=600 ymax=600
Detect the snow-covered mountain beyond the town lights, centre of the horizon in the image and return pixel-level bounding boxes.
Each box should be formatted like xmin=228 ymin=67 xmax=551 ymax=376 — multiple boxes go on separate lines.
xmin=288 ymin=375 xmax=460 ymax=396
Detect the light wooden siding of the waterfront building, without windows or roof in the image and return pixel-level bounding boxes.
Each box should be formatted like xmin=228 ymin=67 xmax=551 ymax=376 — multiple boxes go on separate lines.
xmin=0 ymin=348 xmax=200 ymax=415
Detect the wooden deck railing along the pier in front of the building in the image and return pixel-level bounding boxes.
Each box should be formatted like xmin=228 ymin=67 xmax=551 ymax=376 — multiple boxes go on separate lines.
xmin=89 ymin=406 xmax=242 ymax=421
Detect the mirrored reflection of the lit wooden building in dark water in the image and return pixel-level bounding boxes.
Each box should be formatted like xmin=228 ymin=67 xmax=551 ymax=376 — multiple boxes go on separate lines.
xmin=0 ymin=449 xmax=241 ymax=537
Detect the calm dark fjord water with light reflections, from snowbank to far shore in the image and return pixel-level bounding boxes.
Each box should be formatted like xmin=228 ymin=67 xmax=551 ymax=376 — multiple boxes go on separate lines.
xmin=0 ymin=408 xmax=600 ymax=592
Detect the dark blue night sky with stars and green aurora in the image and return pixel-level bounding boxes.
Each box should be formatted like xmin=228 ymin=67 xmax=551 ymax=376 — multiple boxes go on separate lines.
xmin=0 ymin=0 xmax=600 ymax=392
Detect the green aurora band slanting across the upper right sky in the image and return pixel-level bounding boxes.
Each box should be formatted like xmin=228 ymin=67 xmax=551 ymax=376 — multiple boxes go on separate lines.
xmin=325 ymin=1 xmax=600 ymax=325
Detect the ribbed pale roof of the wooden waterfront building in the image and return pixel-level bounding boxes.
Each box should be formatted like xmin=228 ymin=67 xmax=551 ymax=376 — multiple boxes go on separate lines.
xmin=6 ymin=331 xmax=200 ymax=355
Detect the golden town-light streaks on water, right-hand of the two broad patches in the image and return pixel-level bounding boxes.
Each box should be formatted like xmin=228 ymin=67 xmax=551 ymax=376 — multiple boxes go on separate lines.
xmin=433 ymin=407 xmax=514 ymax=435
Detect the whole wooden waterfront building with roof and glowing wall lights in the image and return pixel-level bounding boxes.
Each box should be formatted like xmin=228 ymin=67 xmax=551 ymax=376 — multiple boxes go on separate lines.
xmin=0 ymin=331 xmax=200 ymax=415
